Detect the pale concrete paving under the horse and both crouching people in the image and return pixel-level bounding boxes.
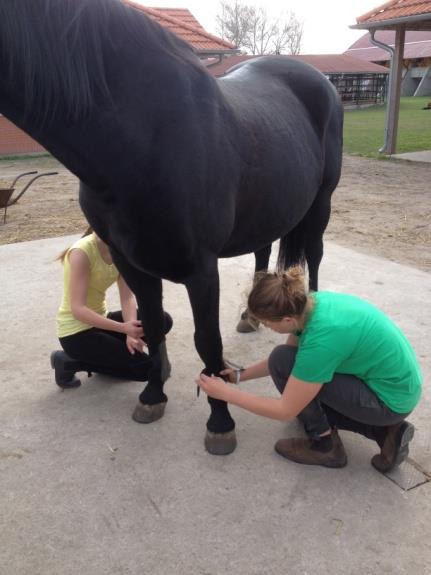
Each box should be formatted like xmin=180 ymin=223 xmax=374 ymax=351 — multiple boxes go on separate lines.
xmin=0 ymin=237 xmax=431 ymax=575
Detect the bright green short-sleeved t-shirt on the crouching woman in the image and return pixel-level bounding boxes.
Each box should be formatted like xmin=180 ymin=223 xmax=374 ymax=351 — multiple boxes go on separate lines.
xmin=292 ymin=292 xmax=422 ymax=413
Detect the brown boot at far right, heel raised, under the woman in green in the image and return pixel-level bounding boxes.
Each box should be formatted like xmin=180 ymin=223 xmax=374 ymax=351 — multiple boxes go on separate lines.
xmin=371 ymin=421 xmax=415 ymax=473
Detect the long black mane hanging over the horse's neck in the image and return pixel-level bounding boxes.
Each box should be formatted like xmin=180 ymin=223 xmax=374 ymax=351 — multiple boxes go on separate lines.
xmin=0 ymin=0 xmax=202 ymax=120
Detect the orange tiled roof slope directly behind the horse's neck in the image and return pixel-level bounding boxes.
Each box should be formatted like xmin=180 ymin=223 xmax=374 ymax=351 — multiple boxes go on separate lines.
xmin=123 ymin=0 xmax=235 ymax=54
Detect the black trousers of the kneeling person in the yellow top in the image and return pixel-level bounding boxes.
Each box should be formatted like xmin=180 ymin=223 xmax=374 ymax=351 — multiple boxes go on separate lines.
xmin=59 ymin=311 xmax=172 ymax=381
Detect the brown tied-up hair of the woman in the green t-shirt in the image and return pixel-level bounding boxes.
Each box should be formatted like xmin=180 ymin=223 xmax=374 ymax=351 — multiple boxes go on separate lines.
xmin=248 ymin=266 xmax=312 ymax=321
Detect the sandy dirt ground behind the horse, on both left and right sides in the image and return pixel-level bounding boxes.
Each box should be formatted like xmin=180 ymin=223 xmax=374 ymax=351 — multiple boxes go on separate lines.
xmin=0 ymin=152 xmax=431 ymax=271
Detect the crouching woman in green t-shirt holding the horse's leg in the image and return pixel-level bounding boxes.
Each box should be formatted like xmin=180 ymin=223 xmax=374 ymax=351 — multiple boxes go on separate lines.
xmin=197 ymin=267 xmax=422 ymax=472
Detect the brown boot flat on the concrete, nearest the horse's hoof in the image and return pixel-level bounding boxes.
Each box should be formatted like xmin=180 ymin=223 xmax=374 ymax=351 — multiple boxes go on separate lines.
xmin=274 ymin=429 xmax=347 ymax=467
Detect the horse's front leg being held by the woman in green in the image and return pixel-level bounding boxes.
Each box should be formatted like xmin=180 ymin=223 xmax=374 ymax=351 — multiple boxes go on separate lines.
xmin=186 ymin=259 xmax=236 ymax=455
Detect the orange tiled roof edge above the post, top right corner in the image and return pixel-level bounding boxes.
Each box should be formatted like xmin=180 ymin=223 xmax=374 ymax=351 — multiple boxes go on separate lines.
xmin=356 ymin=0 xmax=431 ymax=30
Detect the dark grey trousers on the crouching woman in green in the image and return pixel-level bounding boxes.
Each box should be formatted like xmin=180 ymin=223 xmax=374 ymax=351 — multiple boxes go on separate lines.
xmin=268 ymin=345 xmax=408 ymax=443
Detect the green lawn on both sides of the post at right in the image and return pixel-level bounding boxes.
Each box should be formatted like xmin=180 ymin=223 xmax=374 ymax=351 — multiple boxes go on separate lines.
xmin=344 ymin=96 xmax=431 ymax=158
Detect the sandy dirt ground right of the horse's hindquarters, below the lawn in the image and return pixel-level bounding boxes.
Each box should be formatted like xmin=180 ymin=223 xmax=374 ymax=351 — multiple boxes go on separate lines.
xmin=326 ymin=156 xmax=431 ymax=271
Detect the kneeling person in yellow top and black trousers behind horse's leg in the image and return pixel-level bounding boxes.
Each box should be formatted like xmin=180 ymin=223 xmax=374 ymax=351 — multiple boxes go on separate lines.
xmin=51 ymin=228 xmax=172 ymax=388
